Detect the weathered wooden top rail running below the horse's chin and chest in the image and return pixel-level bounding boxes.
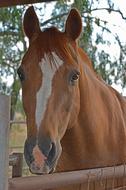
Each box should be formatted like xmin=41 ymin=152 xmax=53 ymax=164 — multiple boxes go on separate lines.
xmin=9 ymin=165 xmax=125 ymax=190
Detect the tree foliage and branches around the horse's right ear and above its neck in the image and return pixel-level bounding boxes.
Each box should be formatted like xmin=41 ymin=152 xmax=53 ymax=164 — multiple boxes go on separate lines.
xmin=50 ymin=0 xmax=126 ymax=88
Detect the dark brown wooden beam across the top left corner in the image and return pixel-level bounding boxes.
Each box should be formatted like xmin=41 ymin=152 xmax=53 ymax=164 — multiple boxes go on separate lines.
xmin=0 ymin=0 xmax=56 ymax=7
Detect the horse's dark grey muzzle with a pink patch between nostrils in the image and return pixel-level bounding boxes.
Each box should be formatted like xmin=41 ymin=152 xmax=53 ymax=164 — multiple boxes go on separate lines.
xmin=24 ymin=139 xmax=62 ymax=174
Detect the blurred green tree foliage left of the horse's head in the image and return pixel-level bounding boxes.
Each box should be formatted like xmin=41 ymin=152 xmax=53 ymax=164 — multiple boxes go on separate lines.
xmin=0 ymin=6 xmax=26 ymax=119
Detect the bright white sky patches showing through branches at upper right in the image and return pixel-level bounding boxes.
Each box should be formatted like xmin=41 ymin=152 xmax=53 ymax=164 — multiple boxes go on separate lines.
xmin=93 ymin=0 xmax=126 ymax=96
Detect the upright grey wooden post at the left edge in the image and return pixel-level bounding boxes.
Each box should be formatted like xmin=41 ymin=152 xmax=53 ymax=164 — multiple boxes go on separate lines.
xmin=0 ymin=95 xmax=10 ymax=190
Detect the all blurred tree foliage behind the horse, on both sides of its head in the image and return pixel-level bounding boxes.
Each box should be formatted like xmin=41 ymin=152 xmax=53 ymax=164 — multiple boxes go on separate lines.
xmin=0 ymin=0 xmax=126 ymax=119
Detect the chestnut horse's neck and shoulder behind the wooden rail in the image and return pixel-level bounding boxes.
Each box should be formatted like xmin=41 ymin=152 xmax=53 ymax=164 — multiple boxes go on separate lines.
xmin=59 ymin=63 xmax=126 ymax=170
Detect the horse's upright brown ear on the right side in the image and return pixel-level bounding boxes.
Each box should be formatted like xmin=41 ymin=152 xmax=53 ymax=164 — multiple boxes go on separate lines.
xmin=65 ymin=9 xmax=82 ymax=40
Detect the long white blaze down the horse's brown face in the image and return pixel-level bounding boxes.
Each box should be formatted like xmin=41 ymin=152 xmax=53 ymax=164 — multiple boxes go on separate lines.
xmin=35 ymin=52 xmax=63 ymax=128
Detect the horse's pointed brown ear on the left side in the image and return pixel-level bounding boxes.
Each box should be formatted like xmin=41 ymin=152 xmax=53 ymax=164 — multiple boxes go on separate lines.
xmin=23 ymin=6 xmax=40 ymax=40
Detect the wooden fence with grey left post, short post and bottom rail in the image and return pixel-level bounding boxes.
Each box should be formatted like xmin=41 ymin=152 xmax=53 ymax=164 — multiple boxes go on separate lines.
xmin=0 ymin=95 xmax=126 ymax=190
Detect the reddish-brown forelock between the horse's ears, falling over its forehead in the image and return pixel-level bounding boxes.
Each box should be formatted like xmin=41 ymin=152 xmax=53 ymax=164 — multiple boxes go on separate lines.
xmin=37 ymin=27 xmax=80 ymax=66
